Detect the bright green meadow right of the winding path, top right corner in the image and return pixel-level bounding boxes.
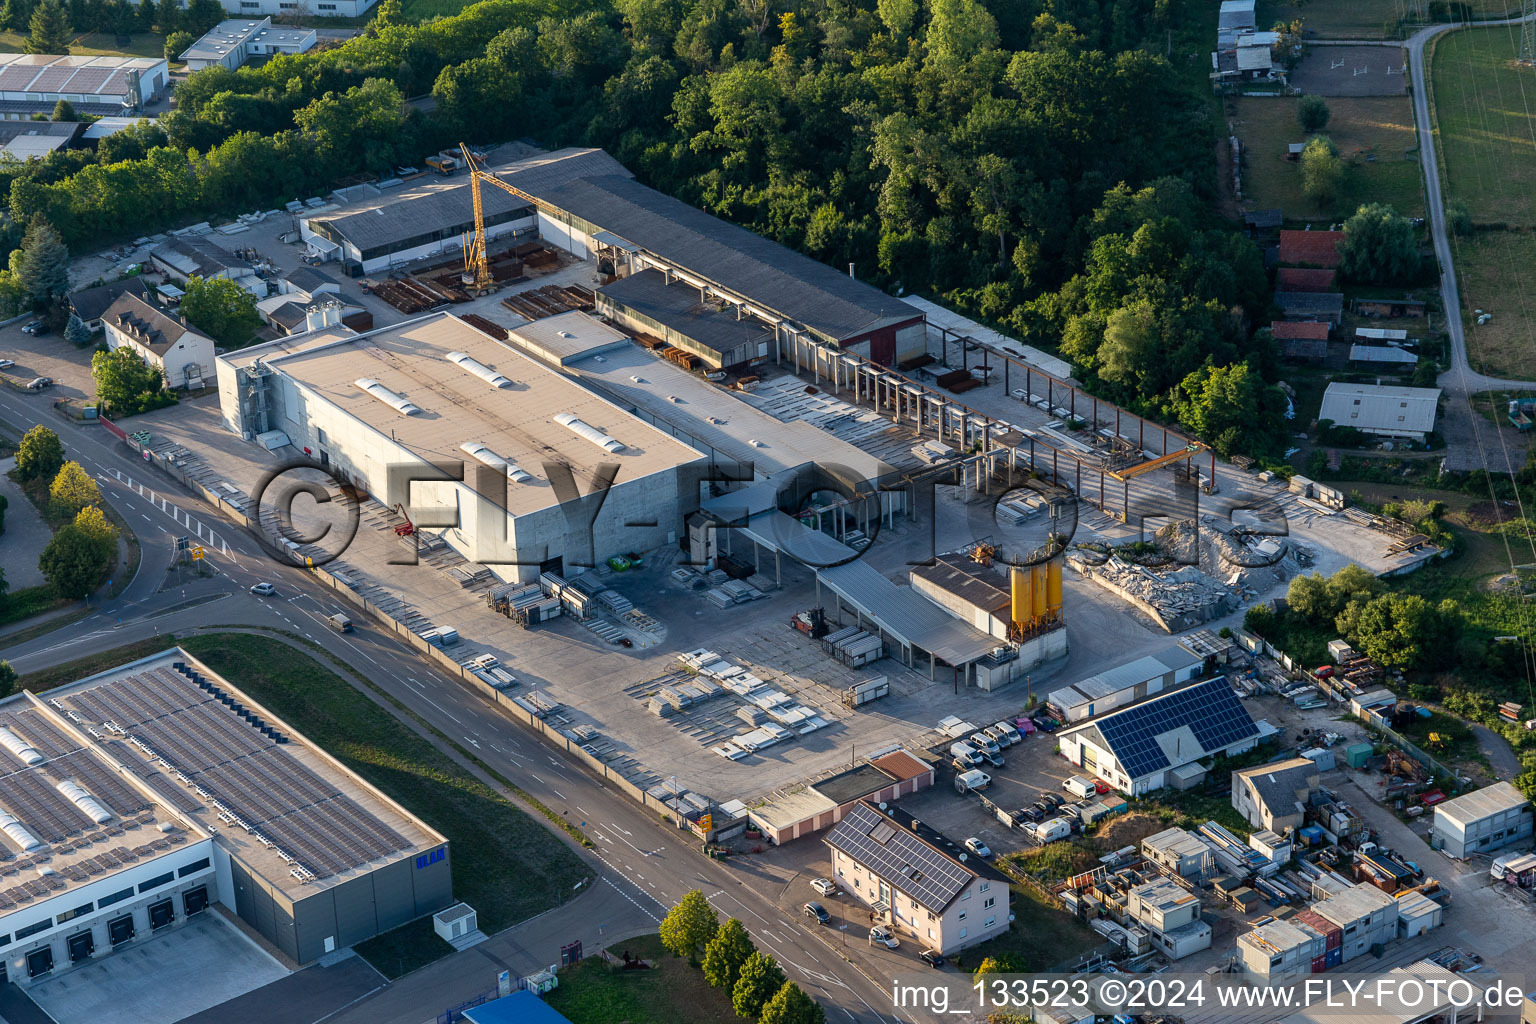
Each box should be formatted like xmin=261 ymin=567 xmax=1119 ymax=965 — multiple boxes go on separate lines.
xmin=1430 ymin=26 xmax=1536 ymax=227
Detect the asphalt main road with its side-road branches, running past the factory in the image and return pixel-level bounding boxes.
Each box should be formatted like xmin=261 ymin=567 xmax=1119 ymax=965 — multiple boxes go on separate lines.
xmin=0 ymin=393 xmax=915 ymax=1024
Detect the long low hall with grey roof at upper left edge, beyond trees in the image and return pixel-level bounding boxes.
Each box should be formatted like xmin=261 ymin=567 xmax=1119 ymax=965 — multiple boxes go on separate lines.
xmin=0 ymin=54 xmax=170 ymax=121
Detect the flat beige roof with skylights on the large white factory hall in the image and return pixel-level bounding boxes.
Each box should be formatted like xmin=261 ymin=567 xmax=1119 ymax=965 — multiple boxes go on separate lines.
xmin=264 ymin=313 xmax=700 ymax=516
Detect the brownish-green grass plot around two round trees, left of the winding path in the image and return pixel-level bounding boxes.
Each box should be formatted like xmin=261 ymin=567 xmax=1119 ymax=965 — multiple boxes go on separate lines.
xmin=1235 ymin=97 xmax=1424 ymax=221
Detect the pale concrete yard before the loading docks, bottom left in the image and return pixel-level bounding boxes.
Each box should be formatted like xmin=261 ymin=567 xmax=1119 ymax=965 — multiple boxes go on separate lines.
xmin=28 ymin=910 xmax=289 ymax=1024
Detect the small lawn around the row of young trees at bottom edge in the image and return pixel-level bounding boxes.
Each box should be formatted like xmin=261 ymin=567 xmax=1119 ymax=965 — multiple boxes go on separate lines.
xmin=544 ymin=935 xmax=739 ymax=1024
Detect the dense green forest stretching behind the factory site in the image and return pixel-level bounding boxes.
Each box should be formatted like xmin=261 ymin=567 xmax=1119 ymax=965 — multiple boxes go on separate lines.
xmin=0 ymin=0 xmax=1286 ymax=454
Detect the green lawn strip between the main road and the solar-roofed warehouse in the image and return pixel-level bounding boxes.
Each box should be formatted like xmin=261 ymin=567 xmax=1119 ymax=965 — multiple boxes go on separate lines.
xmin=169 ymin=634 xmax=587 ymax=970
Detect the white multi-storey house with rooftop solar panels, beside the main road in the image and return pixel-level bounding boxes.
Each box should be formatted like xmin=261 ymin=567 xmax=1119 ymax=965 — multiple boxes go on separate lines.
xmin=823 ymin=801 xmax=1009 ymax=955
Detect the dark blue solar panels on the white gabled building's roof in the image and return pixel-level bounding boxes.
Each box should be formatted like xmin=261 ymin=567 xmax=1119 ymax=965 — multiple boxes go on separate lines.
xmin=1097 ymin=679 xmax=1258 ymax=778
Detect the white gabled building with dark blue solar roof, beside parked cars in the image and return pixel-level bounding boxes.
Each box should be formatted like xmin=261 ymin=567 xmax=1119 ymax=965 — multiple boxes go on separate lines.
xmin=1057 ymin=679 xmax=1266 ymax=797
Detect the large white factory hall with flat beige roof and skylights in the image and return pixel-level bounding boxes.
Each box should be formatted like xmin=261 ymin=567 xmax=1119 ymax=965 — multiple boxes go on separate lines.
xmin=218 ymin=313 xmax=702 ymax=582
